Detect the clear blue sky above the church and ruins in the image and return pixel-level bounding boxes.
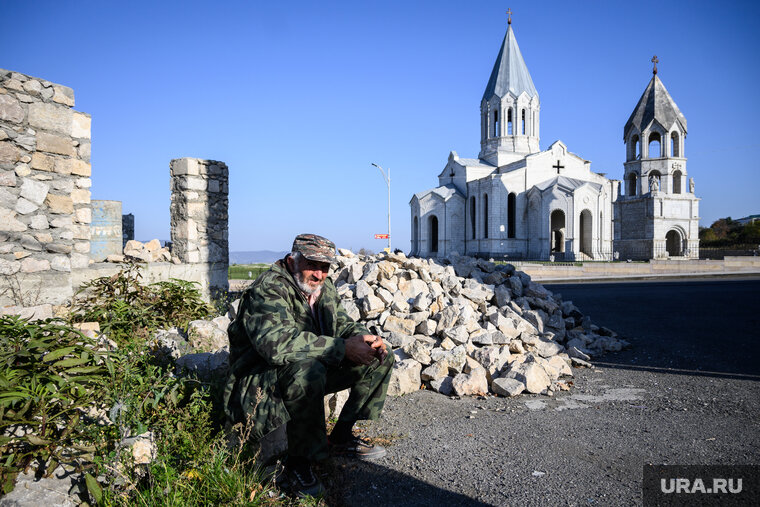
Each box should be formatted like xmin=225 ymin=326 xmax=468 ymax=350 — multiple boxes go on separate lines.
xmin=0 ymin=0 xmax=760 ymax=251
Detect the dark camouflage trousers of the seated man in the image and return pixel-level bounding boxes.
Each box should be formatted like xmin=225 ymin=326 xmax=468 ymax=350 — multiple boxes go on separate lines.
xmin=277 ymin=354 xmax=393 ymax=461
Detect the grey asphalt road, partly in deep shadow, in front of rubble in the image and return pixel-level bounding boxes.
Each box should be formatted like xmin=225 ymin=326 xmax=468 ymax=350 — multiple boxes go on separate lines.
xmin=332 ymin=280 xmax=760 ymax=506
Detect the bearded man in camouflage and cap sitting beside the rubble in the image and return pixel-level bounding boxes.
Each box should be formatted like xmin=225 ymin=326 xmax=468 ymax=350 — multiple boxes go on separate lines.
xmin=224 ymin=234 xmax=393 ymax=495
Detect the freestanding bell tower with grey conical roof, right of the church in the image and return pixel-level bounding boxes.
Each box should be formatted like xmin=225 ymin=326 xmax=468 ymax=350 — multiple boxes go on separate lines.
xmin=614 ymin=56 xmax=699 ymax=259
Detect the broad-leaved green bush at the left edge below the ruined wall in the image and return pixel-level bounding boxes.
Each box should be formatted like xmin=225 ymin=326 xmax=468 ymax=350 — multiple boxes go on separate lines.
xmin=0 ymin=316 xmax=116 ymax=492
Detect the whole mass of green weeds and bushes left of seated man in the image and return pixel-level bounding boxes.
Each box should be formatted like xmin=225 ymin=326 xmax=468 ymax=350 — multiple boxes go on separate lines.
xmin=0 ymin=266 xmax=280 ymax=506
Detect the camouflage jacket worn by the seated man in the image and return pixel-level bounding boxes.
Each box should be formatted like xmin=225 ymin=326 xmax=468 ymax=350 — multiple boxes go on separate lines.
xmin=224 ymin=259 xmax=369 ymax=439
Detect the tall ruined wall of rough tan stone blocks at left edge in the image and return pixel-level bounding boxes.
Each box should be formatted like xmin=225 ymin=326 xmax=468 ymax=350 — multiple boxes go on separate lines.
xmin=0 ymin=69 xmax=91 ymax=304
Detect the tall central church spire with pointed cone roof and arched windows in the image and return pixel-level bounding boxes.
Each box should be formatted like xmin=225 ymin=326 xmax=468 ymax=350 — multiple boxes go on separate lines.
xmin=478 ymin=11 xmax=541 ymax=166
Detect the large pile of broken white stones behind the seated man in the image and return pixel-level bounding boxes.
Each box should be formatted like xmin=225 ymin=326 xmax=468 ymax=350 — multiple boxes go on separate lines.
xmin=331 ymin=249 xmax=628 ymax=396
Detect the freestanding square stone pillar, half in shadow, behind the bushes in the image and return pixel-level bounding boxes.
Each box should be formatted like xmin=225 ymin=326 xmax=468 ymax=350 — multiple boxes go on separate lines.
xmin=170 ymin=158 xmax=229 ymax=297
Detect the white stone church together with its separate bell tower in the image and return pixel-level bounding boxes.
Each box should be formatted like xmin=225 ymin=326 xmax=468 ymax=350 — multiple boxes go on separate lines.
xmin=409 ymin=21 xmax=699 ymax=260
